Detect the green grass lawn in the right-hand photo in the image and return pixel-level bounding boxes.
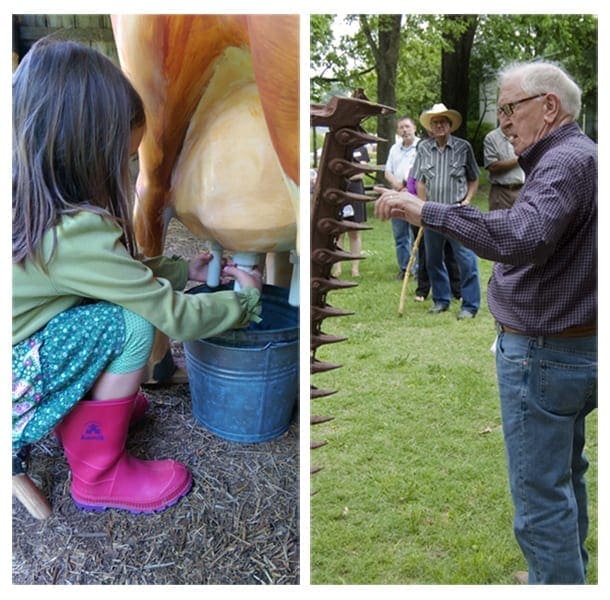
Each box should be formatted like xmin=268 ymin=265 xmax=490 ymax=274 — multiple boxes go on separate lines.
xmin=311 ymin=176 xmax=597 ymax=584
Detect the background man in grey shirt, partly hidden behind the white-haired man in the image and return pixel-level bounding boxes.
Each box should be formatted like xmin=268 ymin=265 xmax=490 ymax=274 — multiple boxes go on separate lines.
xmin=483 ymin=127 xmax=525 ymax=210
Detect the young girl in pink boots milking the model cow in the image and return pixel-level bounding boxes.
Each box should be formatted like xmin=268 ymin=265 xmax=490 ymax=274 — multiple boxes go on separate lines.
xmin=13 ymin=39 xmax=262 ymax=513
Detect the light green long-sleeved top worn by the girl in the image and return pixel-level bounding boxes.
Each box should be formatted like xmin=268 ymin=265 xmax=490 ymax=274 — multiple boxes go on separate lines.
xmin=13 ymin=210 xmax=260 ymax=344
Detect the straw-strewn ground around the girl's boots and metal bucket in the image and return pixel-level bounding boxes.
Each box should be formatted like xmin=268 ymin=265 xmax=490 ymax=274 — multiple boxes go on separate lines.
xmin=13 ymin=385 xmax=299 ymax=585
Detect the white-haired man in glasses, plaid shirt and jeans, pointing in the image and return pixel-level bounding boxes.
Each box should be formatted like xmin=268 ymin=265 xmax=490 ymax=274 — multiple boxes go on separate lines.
xmin=375 ymin=61 xmax=597 ymax=584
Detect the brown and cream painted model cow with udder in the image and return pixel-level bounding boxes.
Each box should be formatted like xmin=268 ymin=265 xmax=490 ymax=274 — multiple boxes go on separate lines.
xmin=112 ymin=15 xmax=299 ymax=384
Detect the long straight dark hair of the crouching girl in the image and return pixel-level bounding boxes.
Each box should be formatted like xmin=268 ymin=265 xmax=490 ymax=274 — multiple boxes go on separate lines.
xmin=13 ymin=38 xmax=145 ymax=264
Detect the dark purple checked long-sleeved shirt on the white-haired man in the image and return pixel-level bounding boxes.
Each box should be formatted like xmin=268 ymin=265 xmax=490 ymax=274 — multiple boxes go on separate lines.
xmin=422 ymin=123 xmax=597 ymax=336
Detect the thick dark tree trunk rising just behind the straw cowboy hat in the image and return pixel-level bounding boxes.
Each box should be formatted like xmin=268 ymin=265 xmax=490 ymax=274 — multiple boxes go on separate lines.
xmin=441 ymin=15 xmax=477 ymax=138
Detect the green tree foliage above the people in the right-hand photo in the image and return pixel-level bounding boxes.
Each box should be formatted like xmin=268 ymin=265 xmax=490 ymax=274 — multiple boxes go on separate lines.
xmin=310 ymin=14 xmax=598 ymax=139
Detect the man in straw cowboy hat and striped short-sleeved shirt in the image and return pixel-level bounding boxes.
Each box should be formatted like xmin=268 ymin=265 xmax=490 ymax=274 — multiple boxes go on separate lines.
xmin=412 ymin=104 xmax=481 ymax=319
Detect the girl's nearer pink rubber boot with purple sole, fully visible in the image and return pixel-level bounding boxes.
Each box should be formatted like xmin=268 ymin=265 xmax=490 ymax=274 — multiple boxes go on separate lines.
xmin=57 ymin=397 xmax=192 ymax=513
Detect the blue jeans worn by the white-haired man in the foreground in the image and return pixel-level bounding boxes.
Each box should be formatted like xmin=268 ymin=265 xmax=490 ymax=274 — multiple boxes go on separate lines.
xmin=496 ymin=333 xmax=597 ymax=584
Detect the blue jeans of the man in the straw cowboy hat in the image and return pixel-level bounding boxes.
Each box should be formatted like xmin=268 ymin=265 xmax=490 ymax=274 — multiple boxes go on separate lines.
xmin=424 ymin=229 xmax=481 ymax=314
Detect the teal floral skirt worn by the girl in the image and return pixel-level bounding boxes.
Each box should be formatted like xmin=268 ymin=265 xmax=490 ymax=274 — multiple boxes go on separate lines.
xmin=13 ymin=302 xmax=125 ymax=452
